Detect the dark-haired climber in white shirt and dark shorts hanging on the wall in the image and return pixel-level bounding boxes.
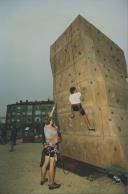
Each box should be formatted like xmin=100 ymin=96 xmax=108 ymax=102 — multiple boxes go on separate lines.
xmin=69 ymin=86 xmax=95 ymax=131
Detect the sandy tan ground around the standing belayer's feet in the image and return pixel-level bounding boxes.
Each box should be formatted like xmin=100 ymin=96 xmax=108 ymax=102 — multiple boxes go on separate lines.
xmin=0 ymin=141 xmax=128 ymax=194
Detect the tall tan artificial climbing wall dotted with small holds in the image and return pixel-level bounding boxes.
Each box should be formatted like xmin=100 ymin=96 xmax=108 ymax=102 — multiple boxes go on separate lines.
xmin=50 ymin=16 xmax=128 ymax=168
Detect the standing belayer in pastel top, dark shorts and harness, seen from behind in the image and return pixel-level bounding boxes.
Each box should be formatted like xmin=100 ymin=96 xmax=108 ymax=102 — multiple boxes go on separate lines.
xmin=40 ymin=119 xmax=61 ymax=190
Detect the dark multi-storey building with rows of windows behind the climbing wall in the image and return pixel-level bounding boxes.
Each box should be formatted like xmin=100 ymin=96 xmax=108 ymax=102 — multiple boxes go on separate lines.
xmin=6 ymin=100 xmax=53 ymax=134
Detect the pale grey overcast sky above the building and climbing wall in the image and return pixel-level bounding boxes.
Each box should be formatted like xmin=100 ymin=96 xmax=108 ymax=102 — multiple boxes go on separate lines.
xmin=0 ymin=0 xmax=128 ymax=116
